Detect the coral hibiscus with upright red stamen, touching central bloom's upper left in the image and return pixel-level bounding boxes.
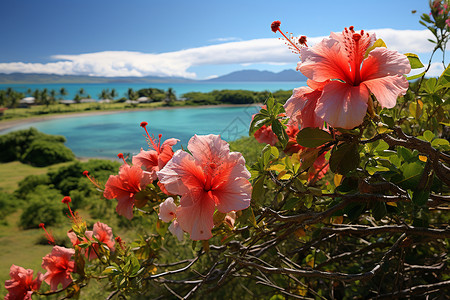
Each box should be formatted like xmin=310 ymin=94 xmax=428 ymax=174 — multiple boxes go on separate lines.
xmin=132 ymin=122 xmax=179 ymax=181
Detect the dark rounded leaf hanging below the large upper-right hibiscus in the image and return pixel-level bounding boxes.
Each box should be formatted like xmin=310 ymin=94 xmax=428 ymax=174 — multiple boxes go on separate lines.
xmin=330 ymin=143 xmax=360 ymax=175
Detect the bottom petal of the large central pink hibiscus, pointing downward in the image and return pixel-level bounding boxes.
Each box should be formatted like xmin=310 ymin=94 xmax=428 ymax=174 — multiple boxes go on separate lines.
xmin=177 ymin=190 xmax=214 ymax=240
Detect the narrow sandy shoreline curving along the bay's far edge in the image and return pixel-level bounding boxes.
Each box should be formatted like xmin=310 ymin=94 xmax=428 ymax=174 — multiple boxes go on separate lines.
xmin=0 ymin=103 xmax=263 ymax=134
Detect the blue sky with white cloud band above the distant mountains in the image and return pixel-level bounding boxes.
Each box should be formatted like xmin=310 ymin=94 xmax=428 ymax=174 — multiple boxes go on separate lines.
xmin=0 ymin=0 xmax=442 ymax=79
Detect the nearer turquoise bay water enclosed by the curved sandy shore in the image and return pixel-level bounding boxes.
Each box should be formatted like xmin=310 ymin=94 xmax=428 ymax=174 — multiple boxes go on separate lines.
xmin=5 ymin=106 xmax=258 ymax=159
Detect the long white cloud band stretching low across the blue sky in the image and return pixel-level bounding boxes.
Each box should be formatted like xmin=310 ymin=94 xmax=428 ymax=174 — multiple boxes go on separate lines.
xmin=0 ymin=28 xmax=442 ymax=78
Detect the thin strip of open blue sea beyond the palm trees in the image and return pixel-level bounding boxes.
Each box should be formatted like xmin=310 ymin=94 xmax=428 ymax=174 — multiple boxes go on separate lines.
xmin=0 ymin=81 xmax=306 ymax=99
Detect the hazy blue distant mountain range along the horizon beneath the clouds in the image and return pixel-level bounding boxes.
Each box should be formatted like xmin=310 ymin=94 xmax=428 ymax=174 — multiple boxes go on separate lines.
xmin=0 ymin=70 xmax=306 ymax=84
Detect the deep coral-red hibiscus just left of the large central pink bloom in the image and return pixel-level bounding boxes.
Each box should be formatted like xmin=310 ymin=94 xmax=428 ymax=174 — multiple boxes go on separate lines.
xmin=103 ymin=164 xmax=152 ymax=220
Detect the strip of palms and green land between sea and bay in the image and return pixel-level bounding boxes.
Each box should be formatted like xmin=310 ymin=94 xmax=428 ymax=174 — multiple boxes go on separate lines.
xmin=0 ymin=88 xmax=292 ymax=122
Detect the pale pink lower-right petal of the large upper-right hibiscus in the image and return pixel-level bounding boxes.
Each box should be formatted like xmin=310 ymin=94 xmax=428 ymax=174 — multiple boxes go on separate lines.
xmin=363 ymin=75 xmax=409 ymax=108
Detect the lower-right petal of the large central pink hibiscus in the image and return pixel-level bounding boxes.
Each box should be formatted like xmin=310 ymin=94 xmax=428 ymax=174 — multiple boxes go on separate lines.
xmin=212 ymin=178 xmax=252 ymax=213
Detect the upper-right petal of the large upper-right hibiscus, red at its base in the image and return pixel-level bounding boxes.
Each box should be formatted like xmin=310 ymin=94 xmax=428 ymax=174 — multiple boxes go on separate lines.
xmin=361 ymin=47 xmax=411 ymax=81
